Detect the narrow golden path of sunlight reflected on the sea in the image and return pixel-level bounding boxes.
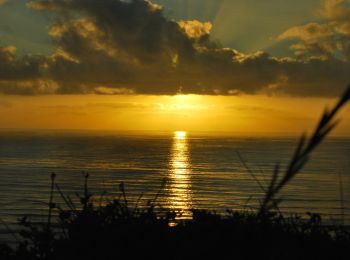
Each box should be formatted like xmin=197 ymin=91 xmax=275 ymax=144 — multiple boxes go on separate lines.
xmin=168 ymin=131 xmax=192 ymax=219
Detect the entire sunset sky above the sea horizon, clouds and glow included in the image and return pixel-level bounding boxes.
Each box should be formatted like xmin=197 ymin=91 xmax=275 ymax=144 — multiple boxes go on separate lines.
xmin=0 ymin=0 xmax=350 ymax=135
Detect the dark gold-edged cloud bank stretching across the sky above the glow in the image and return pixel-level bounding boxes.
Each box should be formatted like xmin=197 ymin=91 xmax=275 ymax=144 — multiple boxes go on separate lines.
xmin=0 ymin=0 xmax=350 ymax=96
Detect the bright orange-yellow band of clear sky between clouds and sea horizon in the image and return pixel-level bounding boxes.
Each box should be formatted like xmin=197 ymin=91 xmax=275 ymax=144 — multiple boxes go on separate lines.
xmin=0 ymin=95 xmax=350 ymax=136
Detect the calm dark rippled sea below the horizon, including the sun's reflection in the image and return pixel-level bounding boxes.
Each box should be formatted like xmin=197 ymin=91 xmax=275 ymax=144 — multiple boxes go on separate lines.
xmin=0 ymin=131 xmax=350 ymax=238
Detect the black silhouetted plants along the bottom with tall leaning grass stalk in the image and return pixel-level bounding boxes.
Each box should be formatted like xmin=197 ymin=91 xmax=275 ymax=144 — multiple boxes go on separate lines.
xmin=0 ymin=88 xmax=350 ymax=260
